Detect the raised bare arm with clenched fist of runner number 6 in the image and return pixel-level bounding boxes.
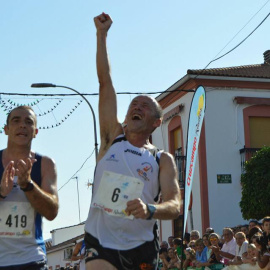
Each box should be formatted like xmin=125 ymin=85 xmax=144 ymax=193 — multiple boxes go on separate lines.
xmin=94 ymin=13 xmax=121 ymax=160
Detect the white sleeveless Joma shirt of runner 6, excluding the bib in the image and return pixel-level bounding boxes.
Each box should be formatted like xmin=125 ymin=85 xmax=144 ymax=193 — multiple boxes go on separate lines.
xmin=85 ymin=134 xmax=161 ymax=250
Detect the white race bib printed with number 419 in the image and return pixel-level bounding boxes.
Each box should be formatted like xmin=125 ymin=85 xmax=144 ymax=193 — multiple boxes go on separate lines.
xmin=0 ymin=201 xmax=34 ymax=238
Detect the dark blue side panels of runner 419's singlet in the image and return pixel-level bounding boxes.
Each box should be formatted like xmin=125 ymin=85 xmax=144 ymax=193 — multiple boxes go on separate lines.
xmin=0 ymin=150 xmax=46 ymax=254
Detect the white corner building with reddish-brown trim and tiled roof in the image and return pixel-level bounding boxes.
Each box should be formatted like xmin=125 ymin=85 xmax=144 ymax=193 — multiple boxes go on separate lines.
xmin=152 ymin=51 xmax=270 ymax=240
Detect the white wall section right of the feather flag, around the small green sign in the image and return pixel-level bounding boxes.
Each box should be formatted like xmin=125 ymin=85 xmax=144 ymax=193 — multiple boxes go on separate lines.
xmin=205 ymin=88 xmax=270 ymax=233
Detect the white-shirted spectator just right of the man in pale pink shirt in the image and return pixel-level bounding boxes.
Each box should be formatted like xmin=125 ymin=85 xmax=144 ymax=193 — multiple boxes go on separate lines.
xmin=228 ymin=232 xmax=248 ymax=265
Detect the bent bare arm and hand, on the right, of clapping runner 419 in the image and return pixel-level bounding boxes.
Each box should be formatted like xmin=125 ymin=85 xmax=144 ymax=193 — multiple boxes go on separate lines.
xmin=16 ymin=156 xmax=59 ymax=220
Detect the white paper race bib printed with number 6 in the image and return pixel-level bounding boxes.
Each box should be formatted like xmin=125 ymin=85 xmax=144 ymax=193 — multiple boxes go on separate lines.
xmin=92 ymin=171 xmax=144 ymax=219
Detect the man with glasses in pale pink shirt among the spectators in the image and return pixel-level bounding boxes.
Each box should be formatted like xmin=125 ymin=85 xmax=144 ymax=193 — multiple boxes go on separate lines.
xmin=212 ymin=228 xmax=236 ymax=264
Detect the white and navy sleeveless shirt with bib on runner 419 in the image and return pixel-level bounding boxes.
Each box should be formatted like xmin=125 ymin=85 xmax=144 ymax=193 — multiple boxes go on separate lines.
xmin=0 ymin=150 xmax=46 ymax=266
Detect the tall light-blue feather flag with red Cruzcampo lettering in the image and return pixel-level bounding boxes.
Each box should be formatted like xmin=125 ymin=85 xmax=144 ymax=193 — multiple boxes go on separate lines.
xmin=183 ymin=86 xmax=205 ymax=235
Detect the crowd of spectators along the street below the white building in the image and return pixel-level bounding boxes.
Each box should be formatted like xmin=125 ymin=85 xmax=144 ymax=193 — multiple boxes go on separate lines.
xmin=159 ymin=216 xmax=270 ymax=270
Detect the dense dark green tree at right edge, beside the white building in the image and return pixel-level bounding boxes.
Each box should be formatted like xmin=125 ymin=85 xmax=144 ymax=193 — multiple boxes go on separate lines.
xmin=240 ymin=146 xmax=270 ymax=220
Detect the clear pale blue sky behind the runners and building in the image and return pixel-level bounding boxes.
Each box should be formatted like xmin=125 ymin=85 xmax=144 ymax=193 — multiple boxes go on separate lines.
xmin=0 ymin=0 xmax=270 ymax=239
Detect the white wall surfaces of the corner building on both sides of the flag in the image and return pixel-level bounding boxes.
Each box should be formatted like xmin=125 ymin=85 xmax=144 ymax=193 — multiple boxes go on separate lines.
xmin=152 ymin=87 xmax=270 ymax=236
